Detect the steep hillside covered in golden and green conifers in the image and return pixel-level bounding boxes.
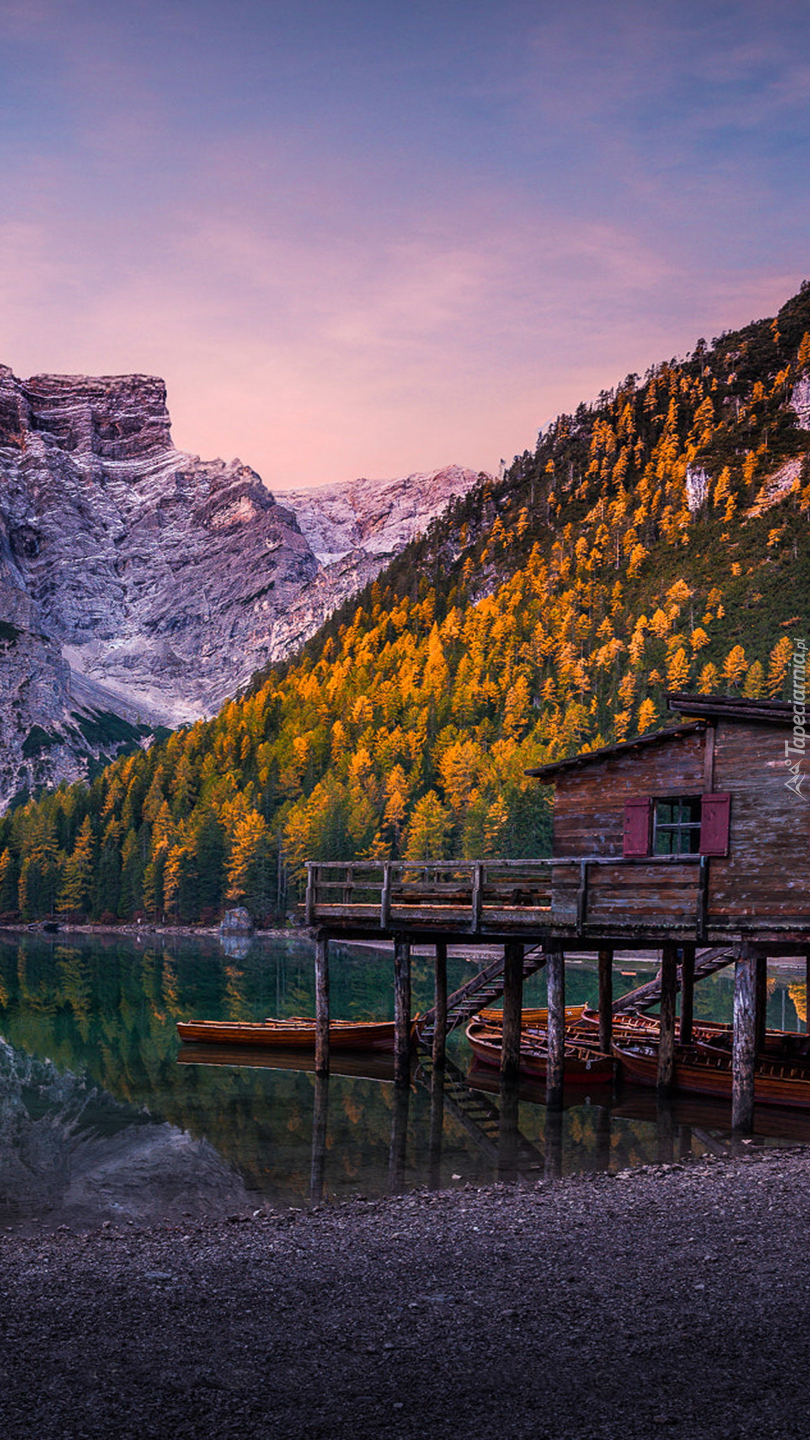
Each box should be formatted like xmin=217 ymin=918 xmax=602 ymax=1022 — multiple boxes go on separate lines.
xmin=0 ymin=284 xmax=810 ymax=920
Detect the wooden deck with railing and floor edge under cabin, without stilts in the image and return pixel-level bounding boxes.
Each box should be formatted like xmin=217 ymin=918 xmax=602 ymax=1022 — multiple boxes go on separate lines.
xmin=304 ymin=854 xmax=810 ymax=955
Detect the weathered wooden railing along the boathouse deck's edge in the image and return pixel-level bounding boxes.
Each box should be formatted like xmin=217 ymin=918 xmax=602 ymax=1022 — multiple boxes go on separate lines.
xmin=304 ymin=855 xmax=709 ymax=940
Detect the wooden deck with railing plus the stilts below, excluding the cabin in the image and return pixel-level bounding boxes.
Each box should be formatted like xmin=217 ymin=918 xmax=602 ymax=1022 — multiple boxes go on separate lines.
xmin=304 ymin=854 xmax=810 ymax=1132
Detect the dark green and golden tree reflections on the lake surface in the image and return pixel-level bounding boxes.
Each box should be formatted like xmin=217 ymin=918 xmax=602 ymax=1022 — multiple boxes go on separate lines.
xmin=0 ymin=935 xmax=810 ymax=1232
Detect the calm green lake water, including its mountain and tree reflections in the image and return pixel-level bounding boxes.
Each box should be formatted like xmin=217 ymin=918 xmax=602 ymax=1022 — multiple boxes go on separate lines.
xmin=0 ymin=935 xmax=810 ymax=1228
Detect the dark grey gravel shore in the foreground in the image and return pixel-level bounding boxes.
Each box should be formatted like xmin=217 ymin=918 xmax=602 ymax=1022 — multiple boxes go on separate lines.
xmin=0 ymin=1148 xmax=810 ymax=1440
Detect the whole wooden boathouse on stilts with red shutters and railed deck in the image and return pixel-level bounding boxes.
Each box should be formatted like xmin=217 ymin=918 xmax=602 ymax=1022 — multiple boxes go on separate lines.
xmin=306 ymin=693 xmax=810 ymax=1130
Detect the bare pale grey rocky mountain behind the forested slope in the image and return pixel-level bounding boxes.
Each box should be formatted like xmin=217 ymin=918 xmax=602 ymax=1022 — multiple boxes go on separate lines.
xmin=0 ymin=367 xmax=477 ymax=804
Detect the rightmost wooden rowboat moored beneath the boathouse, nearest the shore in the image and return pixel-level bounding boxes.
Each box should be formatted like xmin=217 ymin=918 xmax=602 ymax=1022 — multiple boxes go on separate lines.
xmin=613 ymin=1044 xmax=810 ymax=1107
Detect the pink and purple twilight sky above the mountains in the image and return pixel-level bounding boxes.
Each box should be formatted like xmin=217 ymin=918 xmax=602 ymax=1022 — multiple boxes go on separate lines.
xmin=0 ymin=0 xmax=810 ymax=487
